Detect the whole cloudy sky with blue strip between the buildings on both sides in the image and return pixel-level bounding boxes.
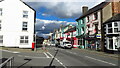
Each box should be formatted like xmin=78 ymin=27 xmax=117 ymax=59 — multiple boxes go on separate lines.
xmin=23 ymin=0 xmax=105 ymax=38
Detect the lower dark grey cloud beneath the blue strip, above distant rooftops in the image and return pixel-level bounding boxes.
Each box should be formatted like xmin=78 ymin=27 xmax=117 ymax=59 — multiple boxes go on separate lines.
xmin=35 ymin=19 xmax=76 ymax=37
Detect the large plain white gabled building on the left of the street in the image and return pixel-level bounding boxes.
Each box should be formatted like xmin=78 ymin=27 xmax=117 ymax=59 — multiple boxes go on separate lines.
xmin=0 ymin=0 xmax=35 ymax=48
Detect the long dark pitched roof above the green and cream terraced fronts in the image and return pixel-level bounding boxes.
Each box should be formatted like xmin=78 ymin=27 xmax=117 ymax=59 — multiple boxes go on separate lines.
xmin=76 ymin=2 xmax=110 ymax=21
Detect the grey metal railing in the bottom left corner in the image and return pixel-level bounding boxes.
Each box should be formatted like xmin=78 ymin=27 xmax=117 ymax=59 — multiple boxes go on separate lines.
xmin=0 ymin=57 xmax=14 ymax=68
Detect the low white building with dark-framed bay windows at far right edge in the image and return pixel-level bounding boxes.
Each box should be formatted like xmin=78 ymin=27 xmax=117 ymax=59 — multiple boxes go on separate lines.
xmin=104 ymin=14 xmax=120 ymax=51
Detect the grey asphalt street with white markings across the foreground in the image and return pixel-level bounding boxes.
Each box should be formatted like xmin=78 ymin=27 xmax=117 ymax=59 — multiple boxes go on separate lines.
xmin=0 ymin=47 xmax=118 ymax=68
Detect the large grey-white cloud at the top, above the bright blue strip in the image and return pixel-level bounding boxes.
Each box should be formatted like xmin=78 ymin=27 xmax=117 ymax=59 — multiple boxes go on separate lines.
xmin=26 ymin=0 xmax=104 ymax=18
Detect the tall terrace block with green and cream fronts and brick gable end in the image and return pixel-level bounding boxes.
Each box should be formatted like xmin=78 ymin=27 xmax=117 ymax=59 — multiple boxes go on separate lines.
xmin=76 ymin=0 xmax=120 ymax=51
